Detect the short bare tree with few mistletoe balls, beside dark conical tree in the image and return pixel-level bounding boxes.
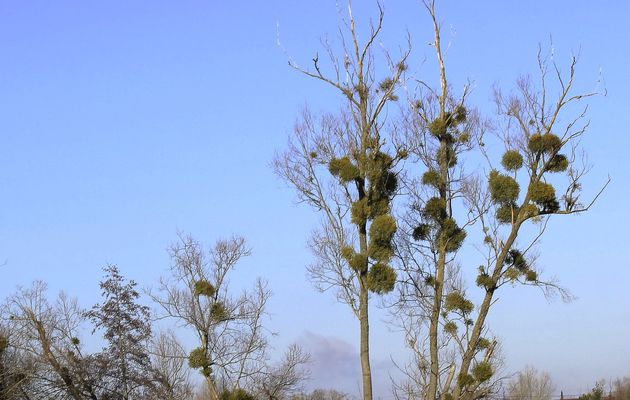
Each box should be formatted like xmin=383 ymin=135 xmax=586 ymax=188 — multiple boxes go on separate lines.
xmin=149 ymin=237 xmax=270 ymax=400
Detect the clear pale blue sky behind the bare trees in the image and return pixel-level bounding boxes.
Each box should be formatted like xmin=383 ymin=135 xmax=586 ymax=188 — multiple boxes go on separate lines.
xmin=0 ymin=0 xmax=630 ymax=398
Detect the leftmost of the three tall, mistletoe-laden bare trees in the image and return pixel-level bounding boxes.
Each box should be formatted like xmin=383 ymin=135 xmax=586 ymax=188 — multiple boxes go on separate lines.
xmin=273 ymin=3 xmax=409 ymax=400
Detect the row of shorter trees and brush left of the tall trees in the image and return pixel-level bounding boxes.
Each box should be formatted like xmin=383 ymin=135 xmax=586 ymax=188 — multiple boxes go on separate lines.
xmin=0 ymin=237 xmax=309 ymax=400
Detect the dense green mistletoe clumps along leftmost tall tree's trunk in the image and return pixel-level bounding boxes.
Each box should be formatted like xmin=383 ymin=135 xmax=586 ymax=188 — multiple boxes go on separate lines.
xmin=328 ymin=146 xmax=404 ymax=294
